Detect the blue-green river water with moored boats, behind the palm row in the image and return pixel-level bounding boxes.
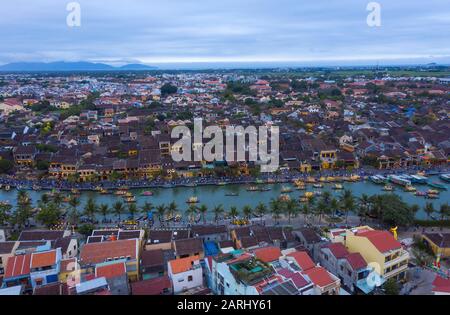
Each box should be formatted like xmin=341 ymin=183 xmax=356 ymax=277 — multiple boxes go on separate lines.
xmin=0 ymin=176 xmax=450 ymax=219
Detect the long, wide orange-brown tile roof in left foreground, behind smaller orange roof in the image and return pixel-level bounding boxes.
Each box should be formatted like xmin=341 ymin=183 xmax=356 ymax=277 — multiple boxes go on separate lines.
xmin=80 ymin=239 xmax=138 ymax=264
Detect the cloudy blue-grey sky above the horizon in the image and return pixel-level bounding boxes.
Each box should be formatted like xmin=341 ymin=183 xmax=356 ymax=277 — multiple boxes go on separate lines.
xmin=0 ymin=0 xmax=450 ymax=65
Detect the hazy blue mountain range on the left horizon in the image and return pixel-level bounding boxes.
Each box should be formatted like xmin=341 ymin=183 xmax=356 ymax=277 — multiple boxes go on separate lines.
xmin=0 ymin=61 xmax=157 ymax=72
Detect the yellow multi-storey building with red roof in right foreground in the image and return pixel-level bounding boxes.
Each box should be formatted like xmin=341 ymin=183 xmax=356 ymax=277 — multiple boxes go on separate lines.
xmin=344 ymin=226 xmax=409 ymax=280
